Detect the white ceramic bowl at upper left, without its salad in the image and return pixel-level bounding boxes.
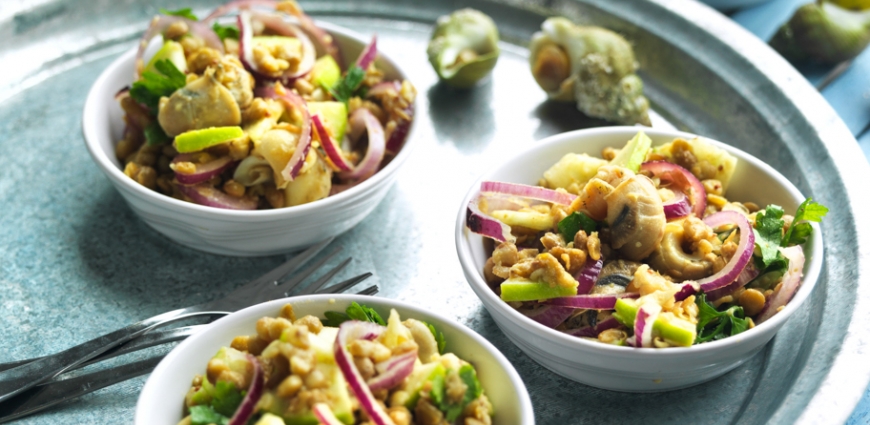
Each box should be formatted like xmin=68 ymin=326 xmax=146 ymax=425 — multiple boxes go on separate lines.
xmin=82 ymin=23 xmax=415 ymax=256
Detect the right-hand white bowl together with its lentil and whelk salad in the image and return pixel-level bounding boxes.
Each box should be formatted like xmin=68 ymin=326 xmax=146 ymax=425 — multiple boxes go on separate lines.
xmin=455 ymin=127 xmax=825 ymax=392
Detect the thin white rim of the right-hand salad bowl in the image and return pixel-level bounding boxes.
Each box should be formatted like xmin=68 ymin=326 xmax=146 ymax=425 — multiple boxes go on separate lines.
xmin=455 ymin=126 xmax=824 ymax=358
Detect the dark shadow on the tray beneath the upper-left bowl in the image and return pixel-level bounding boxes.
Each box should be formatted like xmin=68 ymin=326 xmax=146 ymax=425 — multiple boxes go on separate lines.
xmin=76 ymin=189 xmax=283 ymax=310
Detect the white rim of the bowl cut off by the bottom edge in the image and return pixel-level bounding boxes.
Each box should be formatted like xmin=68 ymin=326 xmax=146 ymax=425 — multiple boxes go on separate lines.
xmin=133 ymin=294 xmax=535 ymax=424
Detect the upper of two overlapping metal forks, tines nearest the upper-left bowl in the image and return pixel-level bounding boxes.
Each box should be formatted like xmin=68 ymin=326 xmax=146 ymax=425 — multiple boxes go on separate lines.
xmin=0 ymin=239 xmax=347 ymax=402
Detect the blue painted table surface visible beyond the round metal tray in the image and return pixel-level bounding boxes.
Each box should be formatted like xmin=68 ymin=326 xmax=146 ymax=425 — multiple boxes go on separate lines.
xmin=730 ymin=0 xmax=870 ymax=425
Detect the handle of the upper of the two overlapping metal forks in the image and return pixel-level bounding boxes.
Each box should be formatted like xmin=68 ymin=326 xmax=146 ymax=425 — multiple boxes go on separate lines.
xmin=0 ymin=306 xmax=225 ymax=402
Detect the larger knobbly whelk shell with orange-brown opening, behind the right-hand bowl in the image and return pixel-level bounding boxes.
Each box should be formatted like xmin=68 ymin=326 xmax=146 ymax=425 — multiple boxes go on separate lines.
xmin=529 ymin=17 xmax=650 ymax=125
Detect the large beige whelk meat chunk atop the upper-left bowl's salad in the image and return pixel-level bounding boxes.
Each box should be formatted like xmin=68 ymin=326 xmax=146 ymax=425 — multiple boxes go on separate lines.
xmin=157 ymin=71 xmax=242 ymax=137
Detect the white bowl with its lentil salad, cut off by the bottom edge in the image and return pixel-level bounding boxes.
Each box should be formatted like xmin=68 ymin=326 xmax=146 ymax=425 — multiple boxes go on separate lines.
xmin=136 ymin=295 xmax=534 ymax=425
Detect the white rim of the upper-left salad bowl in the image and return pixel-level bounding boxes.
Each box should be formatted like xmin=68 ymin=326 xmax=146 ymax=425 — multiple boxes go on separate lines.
xmin=82 ymin=21 xmax=418 ymax=220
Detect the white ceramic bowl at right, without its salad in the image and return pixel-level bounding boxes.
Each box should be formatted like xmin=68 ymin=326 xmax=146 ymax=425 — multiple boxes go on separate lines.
xmin=456 ymin=127 xmax=822 ymax=392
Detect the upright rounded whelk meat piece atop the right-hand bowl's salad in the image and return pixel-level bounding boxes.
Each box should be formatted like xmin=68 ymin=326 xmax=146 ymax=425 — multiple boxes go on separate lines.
xmin=605 ymin=174 xmax=667 ymax=261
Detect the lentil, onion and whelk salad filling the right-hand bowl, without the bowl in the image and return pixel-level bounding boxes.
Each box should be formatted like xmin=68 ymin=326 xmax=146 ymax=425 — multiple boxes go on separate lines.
xmin=466 ymin=132 xmax=827 ymax=348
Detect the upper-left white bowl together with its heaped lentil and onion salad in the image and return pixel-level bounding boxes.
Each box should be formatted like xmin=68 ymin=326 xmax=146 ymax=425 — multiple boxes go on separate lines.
xmin=82 ymin=0 xmax=417 ymax=256
